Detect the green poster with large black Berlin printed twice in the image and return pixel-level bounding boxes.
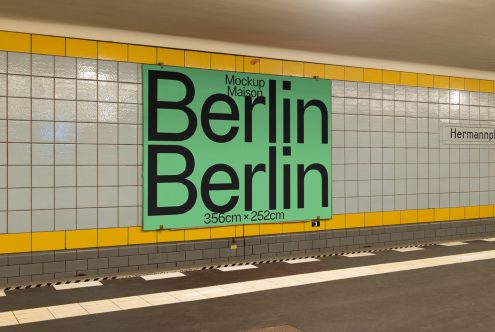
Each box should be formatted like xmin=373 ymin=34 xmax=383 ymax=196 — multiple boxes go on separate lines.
xmin=143 ymin=65 xmax=332 ymax=230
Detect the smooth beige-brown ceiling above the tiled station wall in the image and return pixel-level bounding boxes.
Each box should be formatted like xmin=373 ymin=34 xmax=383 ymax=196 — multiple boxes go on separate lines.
xmin=0 ymin=0 xmax=495 ymax=71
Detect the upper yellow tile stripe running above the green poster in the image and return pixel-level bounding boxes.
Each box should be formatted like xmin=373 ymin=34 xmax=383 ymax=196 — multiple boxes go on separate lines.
xmin=0 ymin=31 xmax=495 ymax=92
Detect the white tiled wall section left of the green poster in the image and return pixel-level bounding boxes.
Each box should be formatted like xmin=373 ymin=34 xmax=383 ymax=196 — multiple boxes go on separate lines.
xmin=0 ymin=52 xmax=142 ymax=233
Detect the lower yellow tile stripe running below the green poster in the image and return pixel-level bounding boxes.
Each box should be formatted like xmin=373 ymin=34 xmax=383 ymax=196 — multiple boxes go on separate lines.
xmin=0 ymin=205 xmax=495 ymax=254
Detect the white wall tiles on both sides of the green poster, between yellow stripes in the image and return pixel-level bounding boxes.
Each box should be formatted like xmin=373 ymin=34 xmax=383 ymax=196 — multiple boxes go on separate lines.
xmin=0 ymin=52 xmax=495 ymax=233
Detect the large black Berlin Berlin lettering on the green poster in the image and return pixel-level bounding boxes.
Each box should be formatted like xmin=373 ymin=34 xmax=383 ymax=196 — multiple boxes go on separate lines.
xmin=147 ymin=70 xmax=329 ymax=215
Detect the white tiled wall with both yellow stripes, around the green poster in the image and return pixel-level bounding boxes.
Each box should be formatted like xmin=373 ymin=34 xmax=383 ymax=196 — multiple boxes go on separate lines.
xmin=0 ymin=32 xmax=495 ymax=260
